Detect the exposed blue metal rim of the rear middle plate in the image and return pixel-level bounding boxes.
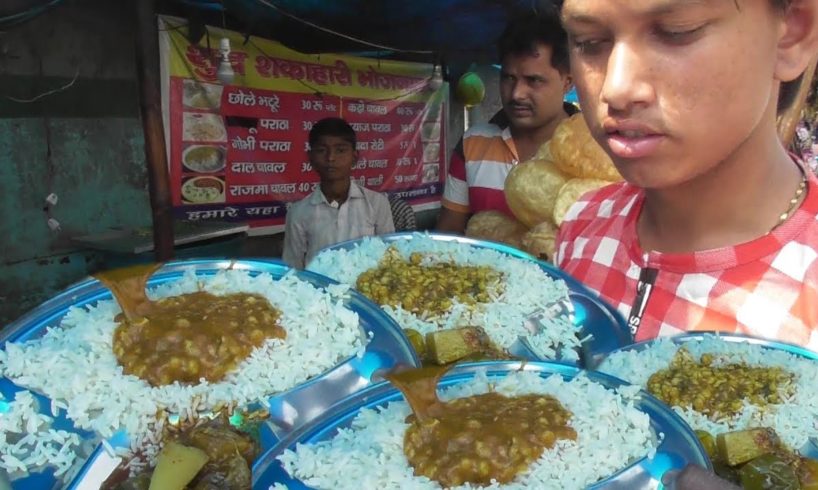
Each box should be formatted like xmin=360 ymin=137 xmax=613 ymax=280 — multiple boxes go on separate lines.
xmin=310 ymin=232 xmax=633 ymax=369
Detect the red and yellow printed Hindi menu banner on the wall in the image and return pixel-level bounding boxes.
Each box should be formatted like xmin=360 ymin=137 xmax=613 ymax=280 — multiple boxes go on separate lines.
xmin=159 ymin=17 xmax=448 ymax=233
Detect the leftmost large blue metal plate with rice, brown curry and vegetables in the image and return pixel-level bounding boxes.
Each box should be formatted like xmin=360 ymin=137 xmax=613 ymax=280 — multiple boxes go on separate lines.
xmin=0 ymin=260 xmax=418 ymax=489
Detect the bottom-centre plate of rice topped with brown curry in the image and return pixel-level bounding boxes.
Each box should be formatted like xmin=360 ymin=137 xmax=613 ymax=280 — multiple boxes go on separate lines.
xmin=253 ymin=361 xmax=709 ymax=490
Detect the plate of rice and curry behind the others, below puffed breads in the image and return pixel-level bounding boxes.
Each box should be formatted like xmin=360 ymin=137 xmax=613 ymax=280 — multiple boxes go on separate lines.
xmin=307 ymin=233 xmax=632 ymax=365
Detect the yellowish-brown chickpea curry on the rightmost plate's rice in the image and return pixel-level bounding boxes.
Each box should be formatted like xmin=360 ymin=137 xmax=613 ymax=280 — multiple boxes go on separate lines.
xmin=648 ymin=348 xmax=793 ymax=420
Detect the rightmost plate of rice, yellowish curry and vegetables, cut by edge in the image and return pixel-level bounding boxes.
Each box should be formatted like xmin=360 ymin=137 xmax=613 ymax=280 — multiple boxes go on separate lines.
xmin=599 ymin=333 xmax=818 ymax=489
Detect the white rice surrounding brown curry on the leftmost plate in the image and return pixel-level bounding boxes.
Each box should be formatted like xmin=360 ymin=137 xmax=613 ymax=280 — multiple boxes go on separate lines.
xmin=0 ymin=270 xmax=366 ymax=478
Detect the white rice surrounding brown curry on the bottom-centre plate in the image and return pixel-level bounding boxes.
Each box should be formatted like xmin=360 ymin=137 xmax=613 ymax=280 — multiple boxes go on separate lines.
xmin=272 ymin=372 xmax=658 ymax=490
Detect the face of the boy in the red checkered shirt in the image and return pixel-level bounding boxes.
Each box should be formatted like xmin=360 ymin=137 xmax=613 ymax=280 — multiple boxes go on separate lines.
xmin=562 ymin=0 xmax=783 ymax=188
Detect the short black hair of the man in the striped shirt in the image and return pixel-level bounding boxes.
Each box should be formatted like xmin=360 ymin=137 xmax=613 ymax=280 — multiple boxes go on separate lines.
xmin=497 ymin=6 xmax=569 ymax=73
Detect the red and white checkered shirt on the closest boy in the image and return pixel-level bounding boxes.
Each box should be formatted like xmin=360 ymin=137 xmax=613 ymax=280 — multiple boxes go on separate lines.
xmin=555 ymin=172 xmax=818 ymax=351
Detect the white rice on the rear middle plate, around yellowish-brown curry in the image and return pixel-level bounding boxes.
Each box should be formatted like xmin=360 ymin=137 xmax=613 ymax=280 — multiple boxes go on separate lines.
xmin=307 ymin=233 xmax=579 ymax=360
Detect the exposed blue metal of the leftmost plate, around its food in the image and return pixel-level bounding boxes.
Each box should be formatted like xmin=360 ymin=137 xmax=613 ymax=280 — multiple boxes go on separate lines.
xmin=0 ymin=259 xmax=419 ymax=490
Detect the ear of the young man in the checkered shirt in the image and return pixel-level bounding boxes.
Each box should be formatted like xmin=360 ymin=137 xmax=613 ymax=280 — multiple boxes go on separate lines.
xmin=776 ymin=0 xmax=818 ymax=82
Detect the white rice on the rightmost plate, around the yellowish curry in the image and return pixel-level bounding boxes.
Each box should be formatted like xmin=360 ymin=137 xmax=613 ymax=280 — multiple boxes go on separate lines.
xmin=599 ymin=335 xmax=818 ymax=450
